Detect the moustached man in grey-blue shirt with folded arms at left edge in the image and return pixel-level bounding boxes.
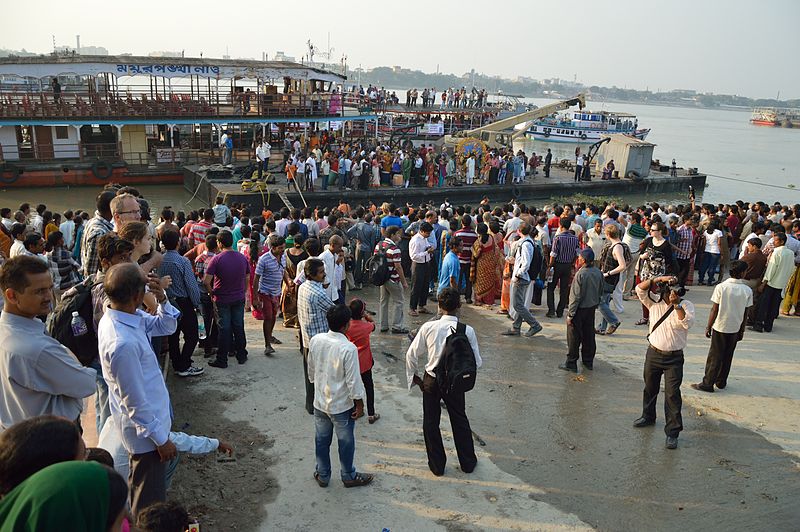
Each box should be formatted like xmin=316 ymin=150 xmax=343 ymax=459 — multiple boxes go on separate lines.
xmin=0 ymin=256 xmax=95 ymax=432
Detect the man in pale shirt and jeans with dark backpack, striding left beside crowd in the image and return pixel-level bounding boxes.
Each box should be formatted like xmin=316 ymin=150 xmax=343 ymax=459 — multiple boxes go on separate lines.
xmin=502 ymin=222 xmax=543 ymax=337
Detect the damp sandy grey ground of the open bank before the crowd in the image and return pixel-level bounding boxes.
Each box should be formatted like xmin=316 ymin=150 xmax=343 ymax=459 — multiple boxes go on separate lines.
xmin=84 ymin=280 xmax=800 ymax=531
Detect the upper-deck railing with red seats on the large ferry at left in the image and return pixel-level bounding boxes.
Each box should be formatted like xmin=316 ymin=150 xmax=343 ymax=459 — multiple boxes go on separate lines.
xmin=0 ymin=88 xmax=372 ymax=119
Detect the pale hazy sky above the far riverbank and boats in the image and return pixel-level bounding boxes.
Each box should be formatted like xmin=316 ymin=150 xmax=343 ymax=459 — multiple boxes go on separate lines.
xmin=0 ymin=0 xmax=800 ymax=99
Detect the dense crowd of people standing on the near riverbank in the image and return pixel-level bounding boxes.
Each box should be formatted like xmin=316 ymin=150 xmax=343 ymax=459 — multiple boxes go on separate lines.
xmin=0 ymin=185 xmax=800 ymax=531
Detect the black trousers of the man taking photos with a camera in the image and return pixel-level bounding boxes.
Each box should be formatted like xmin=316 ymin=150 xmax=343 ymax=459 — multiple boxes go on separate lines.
xmin=642 ymin=345 xmax=683 ymax=437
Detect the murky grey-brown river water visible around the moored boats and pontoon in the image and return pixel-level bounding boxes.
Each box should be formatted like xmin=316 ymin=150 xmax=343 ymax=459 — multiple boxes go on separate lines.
xmin=0 ymin=100 xmax=800 ymax=215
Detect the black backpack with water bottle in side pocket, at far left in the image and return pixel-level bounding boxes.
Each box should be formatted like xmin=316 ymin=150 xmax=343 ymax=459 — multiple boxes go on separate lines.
xmin=47 ymin=281 xmax=100 ymax=366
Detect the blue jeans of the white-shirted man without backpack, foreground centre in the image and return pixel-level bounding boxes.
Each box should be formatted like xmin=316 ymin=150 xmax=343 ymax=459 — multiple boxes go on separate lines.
xmin=314 ymin=408 xmax=356 ymax=482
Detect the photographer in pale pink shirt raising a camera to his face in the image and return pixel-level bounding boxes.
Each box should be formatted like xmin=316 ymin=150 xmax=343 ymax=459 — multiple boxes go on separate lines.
xmin=633 ymin=275 xmax=694 ymax=449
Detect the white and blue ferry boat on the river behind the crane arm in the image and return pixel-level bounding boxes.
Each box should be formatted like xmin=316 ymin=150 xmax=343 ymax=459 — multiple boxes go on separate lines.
xmin=525 ymin=110 xmax=650 ymax=144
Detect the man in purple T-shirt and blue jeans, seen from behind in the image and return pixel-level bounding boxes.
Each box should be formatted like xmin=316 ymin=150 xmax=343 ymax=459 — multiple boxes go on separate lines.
xmin=203 ymin=230 xmax=250 ymax=368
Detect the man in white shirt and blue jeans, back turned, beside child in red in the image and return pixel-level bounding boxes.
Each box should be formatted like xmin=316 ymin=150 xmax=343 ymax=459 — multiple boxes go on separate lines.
xmin=308 ymin=305 xmax=374 ymax=488
